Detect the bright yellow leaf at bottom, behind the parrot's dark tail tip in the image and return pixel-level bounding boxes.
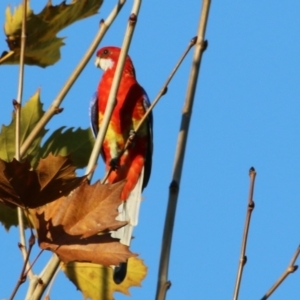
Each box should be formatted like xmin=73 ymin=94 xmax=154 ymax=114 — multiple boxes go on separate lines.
xmin=62 ymin=257 xmax=147 ymax=300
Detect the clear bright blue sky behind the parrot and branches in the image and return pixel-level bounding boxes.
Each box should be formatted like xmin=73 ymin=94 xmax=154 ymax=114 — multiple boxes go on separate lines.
xmin=0 ymin=0 xmax=300 ymax=300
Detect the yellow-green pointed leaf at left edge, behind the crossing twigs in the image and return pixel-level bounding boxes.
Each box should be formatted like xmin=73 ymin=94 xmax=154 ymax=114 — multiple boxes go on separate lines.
xmin=0 ymin=90 xmax=47 ymax=161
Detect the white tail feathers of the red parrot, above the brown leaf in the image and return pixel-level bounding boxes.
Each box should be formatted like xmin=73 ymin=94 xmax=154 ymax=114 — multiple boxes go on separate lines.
xmin=111 ymin=168 xmax=144 ymax=246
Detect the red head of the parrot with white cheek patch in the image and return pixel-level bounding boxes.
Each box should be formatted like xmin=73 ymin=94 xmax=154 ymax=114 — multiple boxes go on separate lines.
xmin=95 ymin=46 xmax=133 ymax=71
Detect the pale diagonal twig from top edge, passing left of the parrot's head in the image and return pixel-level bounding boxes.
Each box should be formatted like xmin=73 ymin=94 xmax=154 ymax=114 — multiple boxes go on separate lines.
xmin=20 ymin=0 xmax=126 ymax=157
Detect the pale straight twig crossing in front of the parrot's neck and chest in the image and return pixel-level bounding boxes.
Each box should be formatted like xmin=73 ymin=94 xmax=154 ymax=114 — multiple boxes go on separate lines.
xmin=85 ymin=0 xmax=141 ymax=180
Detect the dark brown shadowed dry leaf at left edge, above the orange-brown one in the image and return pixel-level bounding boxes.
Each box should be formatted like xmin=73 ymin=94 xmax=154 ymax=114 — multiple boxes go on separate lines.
xmin=0 ymin=154 xmax=86 ymax=208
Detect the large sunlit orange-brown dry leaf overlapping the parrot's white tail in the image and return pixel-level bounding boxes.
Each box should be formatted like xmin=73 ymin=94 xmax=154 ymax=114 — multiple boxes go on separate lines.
xmin=30 ymin=182 xmax=135 ymax=266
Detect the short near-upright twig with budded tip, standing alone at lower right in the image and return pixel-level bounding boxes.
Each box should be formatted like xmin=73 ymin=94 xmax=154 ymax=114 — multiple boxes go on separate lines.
xmin=233 ymin=167 xmax=256 ymax=300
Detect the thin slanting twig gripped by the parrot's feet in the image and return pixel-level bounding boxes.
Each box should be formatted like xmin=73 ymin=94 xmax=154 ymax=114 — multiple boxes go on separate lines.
xmin=102 ymin=37 xmax=197 ymax=183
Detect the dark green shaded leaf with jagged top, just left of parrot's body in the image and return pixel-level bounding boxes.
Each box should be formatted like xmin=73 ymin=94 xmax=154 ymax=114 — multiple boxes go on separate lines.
xmin=40 ymin=127 xmax=95 ymax=168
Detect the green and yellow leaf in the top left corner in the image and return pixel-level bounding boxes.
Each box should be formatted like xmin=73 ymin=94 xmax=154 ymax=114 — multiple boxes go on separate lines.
xmin=0 ymin=0 xmax=103 ymax=67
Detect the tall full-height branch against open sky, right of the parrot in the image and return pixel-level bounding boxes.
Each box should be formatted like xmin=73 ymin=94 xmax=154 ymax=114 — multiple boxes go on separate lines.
xmin=156 ymin=0 xmax=211 ymax=300
